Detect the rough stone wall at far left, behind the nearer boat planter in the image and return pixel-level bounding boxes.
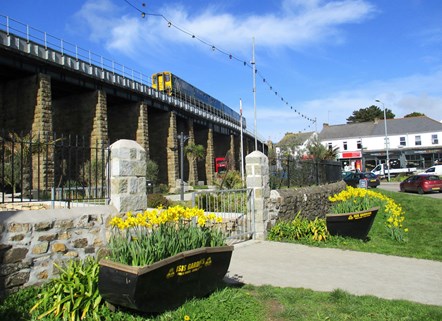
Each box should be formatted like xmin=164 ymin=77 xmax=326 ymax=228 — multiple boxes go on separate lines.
xmin=0 ymin=206 xmax=117 ymax=298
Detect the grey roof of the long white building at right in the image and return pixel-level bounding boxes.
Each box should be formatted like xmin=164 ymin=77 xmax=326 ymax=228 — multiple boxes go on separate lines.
xmin=319 ymin=116 xmax=442 ymax=140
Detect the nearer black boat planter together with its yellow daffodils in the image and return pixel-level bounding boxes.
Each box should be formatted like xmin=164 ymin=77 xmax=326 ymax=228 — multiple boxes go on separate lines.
xmin=99 ymin=206 xmax=233 ymax=313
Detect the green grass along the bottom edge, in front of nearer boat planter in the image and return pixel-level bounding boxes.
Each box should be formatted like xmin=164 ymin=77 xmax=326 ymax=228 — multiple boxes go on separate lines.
xmin=0 ymin=285 xmax=442 ymax=321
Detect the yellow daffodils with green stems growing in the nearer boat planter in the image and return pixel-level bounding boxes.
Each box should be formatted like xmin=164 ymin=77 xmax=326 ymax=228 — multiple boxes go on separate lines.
xmin=109 ymin=206 xmax=225 ymax=266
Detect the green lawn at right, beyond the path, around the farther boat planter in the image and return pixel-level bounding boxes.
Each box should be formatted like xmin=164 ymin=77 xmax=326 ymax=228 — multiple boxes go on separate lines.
xmin=286 ymin=190 xmax=442 ymax=261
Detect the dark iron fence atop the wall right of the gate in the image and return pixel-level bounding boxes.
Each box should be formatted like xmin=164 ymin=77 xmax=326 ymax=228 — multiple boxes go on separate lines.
xmin=269 ymin=156 xmax=342 ymax=189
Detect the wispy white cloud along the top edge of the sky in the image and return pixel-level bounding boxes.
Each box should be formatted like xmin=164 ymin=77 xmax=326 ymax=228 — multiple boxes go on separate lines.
xmin=73 ymin=0 xmax=375 ymax=54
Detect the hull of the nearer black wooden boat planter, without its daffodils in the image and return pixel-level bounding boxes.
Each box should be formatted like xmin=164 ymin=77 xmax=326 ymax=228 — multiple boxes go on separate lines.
xmin=98 ymin=246 xmax=233 ymax=313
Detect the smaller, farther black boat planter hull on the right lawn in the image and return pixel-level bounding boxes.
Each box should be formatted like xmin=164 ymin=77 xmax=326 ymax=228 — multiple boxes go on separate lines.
xmin=325 ymin=207 xmax=379 ymax=240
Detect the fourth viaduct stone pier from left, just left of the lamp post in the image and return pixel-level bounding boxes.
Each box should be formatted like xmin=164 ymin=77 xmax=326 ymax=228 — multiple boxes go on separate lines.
xmin=167 ymin=112 xmax=179 ymax=188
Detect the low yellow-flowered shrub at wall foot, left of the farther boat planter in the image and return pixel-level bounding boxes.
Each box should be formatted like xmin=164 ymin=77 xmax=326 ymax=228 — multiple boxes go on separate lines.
xmin=267 ymin=212 xmax=329 ymax=242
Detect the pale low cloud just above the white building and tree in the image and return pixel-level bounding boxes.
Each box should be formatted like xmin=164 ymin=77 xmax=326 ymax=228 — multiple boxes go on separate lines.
xmin=254 ymin=70 xmax=442 ymax=142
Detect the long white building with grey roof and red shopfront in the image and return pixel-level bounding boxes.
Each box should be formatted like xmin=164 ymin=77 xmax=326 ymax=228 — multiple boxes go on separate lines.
xmin=319 ymin=116 xmax=442 ymax=170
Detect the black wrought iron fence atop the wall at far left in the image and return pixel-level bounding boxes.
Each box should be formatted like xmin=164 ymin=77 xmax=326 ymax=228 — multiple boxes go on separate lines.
xmin=0 ymin=132 xmax=110 ymax=207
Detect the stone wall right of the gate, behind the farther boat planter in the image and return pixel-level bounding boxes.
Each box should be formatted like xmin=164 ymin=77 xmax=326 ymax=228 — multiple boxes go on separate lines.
xmin=267 ymin=181 xmax=346 ymax=230
